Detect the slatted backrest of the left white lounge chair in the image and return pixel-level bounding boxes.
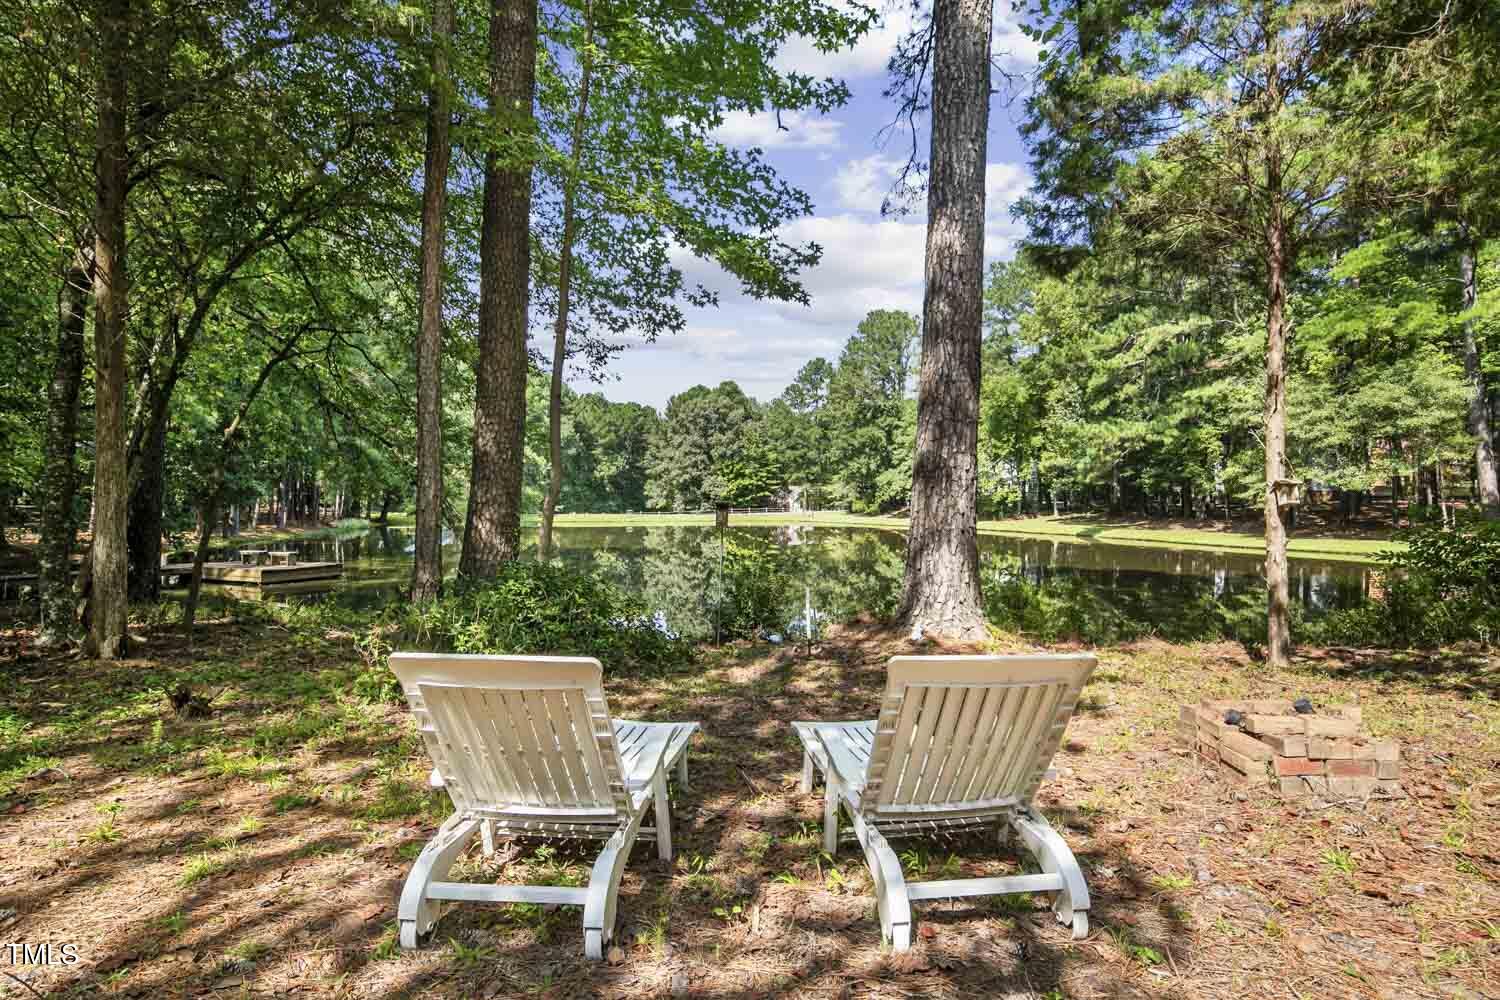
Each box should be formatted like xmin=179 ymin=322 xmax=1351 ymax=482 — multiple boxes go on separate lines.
xmin=390 ymin=652 xmax=629 ymax=822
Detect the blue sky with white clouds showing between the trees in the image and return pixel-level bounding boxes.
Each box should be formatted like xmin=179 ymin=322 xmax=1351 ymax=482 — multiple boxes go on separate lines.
xmin=573 ymin=3 xmax=1035 ymax=409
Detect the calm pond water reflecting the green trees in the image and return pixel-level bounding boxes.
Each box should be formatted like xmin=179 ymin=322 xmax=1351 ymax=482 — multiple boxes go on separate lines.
xmin=175 ymin=525 xmax=1371 ymax=636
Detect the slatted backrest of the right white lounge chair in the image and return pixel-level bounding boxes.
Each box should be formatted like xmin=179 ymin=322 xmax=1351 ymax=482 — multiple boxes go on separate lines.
xmin=864 ymin=655 xmax=1095 ymax=814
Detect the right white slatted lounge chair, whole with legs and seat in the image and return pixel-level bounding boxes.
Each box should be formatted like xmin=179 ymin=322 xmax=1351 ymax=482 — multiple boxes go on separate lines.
xmin=792 ymin=655 xmax=1095 ymax=951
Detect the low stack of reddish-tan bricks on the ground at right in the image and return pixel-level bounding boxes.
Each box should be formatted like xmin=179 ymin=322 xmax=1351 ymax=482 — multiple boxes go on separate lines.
xmin=1178 ymin=699 xmax=1403 ymax=798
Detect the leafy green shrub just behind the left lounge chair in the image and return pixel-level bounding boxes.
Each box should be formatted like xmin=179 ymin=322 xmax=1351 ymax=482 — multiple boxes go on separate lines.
xmin=360 ymin=562 xmax=693 ymax=683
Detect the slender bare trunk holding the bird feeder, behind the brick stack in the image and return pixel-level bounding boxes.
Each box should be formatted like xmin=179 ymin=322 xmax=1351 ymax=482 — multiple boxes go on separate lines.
xmin=1265 ymin=205 xmax=1292 ymax=666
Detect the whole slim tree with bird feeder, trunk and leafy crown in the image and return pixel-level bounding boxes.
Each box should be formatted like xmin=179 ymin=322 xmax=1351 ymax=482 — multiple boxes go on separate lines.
xmin=1025 ymin=0 xmax=1389 ymax=664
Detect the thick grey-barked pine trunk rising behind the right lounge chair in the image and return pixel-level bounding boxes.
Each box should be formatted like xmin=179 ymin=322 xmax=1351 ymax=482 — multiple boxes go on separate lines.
xmin=899 ymin=0 xmax=993 ymax=639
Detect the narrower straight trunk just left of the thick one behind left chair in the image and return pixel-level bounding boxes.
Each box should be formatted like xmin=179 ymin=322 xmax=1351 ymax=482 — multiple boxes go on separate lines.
xmin=411 ymin=0 xmax=453 ymax=601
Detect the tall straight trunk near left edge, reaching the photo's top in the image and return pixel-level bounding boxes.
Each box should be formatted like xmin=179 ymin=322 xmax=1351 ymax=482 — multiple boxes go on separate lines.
xmin=89 ymin=0 xmax=131 ymax=660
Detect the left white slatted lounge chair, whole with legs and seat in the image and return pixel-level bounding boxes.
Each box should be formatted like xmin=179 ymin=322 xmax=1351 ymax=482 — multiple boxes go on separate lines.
xmin=390 ymin=652 xmax=698 ymax=958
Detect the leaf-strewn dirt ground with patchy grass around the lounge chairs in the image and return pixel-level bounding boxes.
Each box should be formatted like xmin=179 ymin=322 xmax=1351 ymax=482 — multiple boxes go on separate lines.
xmin=0 ymin=621 xmax=1500 ymax=1000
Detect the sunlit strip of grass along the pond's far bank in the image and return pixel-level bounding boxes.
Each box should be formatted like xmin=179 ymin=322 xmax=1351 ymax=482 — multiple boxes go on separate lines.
xmin=543 ymin=513 xmax=1406 ymax=562
